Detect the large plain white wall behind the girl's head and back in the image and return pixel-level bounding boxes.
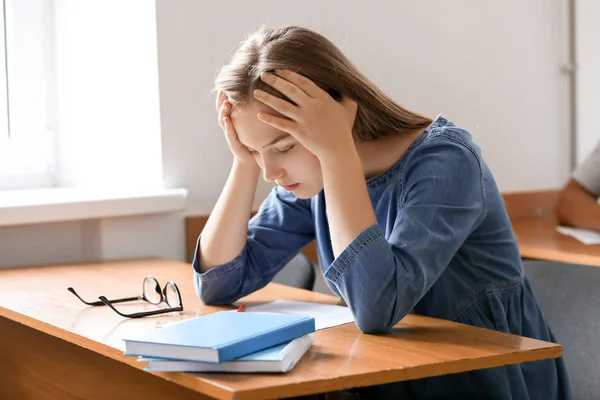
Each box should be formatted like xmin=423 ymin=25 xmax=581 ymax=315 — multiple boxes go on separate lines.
xmin=157 ymin=0 xmax=570 ymax=214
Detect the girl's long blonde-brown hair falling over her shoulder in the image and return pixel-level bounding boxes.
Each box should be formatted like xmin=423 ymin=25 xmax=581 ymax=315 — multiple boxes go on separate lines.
xmin=215 ymin=26 xmax=432 ymax=140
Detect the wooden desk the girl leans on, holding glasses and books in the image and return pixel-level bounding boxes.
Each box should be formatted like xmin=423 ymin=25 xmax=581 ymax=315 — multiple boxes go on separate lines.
xmin=0 ymin=260 xmax=562 ymax=400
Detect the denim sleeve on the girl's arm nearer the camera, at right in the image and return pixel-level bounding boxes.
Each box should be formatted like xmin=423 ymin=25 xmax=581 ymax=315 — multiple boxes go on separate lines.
xmin=325 ymin=138 xmax=484 ymax=333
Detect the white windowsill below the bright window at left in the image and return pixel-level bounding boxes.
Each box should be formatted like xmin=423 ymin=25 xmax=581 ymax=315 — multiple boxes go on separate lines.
xmin=0 ymin=188 xmax=187 ymax=226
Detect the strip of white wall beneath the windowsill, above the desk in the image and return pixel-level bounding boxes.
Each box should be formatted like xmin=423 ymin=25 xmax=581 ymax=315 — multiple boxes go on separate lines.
xmin=0 ymin=213 xmax=185 ymax=268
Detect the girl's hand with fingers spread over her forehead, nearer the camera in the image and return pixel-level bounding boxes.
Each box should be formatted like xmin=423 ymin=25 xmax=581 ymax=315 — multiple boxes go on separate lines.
xmin=254 ymin=70 xmax=358 ymax=159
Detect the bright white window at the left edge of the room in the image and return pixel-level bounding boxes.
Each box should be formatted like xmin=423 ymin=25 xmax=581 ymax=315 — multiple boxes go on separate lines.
xmin=0 ymin=0 xmax=56 ymax=190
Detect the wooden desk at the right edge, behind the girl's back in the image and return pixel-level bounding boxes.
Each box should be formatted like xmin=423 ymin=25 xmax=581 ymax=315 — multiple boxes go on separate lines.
xmin=512 ymin=217 xmax=600 ymax=267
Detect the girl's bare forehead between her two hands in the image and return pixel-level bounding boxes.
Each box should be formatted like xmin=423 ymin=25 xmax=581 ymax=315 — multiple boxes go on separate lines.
xmin=231 ymin=101 xmax=284 ymax=149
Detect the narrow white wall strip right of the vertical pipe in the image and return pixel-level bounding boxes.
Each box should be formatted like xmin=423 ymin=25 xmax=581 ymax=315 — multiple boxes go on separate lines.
xmin=575 ymin=0 xmax=600 ymax=162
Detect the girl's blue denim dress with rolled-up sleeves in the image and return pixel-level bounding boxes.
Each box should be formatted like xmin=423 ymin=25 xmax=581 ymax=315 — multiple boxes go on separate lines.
xmin=193 ymin=116 xmax=570 ymax=400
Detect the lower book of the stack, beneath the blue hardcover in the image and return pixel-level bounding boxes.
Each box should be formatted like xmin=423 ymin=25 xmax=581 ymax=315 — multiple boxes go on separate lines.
xmin=138 ymin=333 xmax=315 ymax=373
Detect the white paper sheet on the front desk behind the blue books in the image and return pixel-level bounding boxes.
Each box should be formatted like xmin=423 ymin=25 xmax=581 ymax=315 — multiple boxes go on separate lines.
xmin=245 ymin=300 xmax=354 ymax=330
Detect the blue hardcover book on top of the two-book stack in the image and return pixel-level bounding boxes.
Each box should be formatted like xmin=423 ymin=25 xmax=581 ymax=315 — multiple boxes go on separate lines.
xmin=123 ymin=311 xmax=315 ymax=363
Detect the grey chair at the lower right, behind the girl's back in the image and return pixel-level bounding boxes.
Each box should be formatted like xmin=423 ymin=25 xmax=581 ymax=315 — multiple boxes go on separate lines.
xmin=523 ymin=261 xmax=600 ymax=399
